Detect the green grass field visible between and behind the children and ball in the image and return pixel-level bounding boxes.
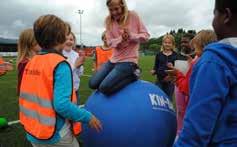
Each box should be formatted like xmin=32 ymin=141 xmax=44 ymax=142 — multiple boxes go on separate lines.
xmin=0 ymin=56 xmax=155 ymax=147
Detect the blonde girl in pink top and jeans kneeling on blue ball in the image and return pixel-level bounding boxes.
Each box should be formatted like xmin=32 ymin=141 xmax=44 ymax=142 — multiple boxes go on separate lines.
xmin=89 ymin=0 xmax=149 ymax=95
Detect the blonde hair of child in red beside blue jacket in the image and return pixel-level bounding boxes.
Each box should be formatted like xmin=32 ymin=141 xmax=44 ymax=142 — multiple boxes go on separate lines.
xmin=191 ymin=30 xmax=217 ymax=52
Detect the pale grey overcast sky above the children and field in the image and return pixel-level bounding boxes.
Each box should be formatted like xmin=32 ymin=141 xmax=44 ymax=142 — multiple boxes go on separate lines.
xmin=0 ymin=0 xmax=215 ymax=46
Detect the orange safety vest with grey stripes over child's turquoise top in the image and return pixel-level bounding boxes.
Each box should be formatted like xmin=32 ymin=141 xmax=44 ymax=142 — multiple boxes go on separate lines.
xmin=19 ymin=53 xmax=81 ymax=140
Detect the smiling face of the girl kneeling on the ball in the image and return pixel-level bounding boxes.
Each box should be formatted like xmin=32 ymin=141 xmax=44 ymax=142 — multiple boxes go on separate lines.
xmin=108 ymin=0 xmax=123 ymax=21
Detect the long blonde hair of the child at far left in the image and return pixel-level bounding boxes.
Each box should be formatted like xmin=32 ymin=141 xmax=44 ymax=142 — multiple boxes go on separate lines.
xmin=17 ymin=29 xmax=37 ymax=66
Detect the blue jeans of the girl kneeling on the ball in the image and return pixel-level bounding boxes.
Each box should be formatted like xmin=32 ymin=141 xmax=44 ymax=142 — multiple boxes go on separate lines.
xmin=89 ymin=61 xmax=138 ymax=95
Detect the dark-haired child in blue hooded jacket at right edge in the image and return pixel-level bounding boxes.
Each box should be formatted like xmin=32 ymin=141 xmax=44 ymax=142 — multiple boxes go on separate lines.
xmin=175 ymin=0 xmax=237 ymax=147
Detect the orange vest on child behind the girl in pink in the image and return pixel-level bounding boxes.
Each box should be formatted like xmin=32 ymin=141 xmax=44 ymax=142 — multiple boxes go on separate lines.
xmin=95 ymin=47 xmax=112 ymax=70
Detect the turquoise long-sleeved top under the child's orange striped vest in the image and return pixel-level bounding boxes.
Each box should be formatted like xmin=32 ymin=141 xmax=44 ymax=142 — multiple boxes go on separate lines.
xmin=26 ymin=55 xmax=92 ymax=144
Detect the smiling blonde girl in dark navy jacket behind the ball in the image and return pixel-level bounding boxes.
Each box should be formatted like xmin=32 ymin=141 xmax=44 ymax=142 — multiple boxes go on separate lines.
xmin=151 ymin=34 xmax=177 ymax=100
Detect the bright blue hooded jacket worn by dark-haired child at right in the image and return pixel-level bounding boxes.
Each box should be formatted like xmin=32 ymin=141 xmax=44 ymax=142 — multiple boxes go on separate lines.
xmin=174 ymin=39 xmax=237 ymax=147
